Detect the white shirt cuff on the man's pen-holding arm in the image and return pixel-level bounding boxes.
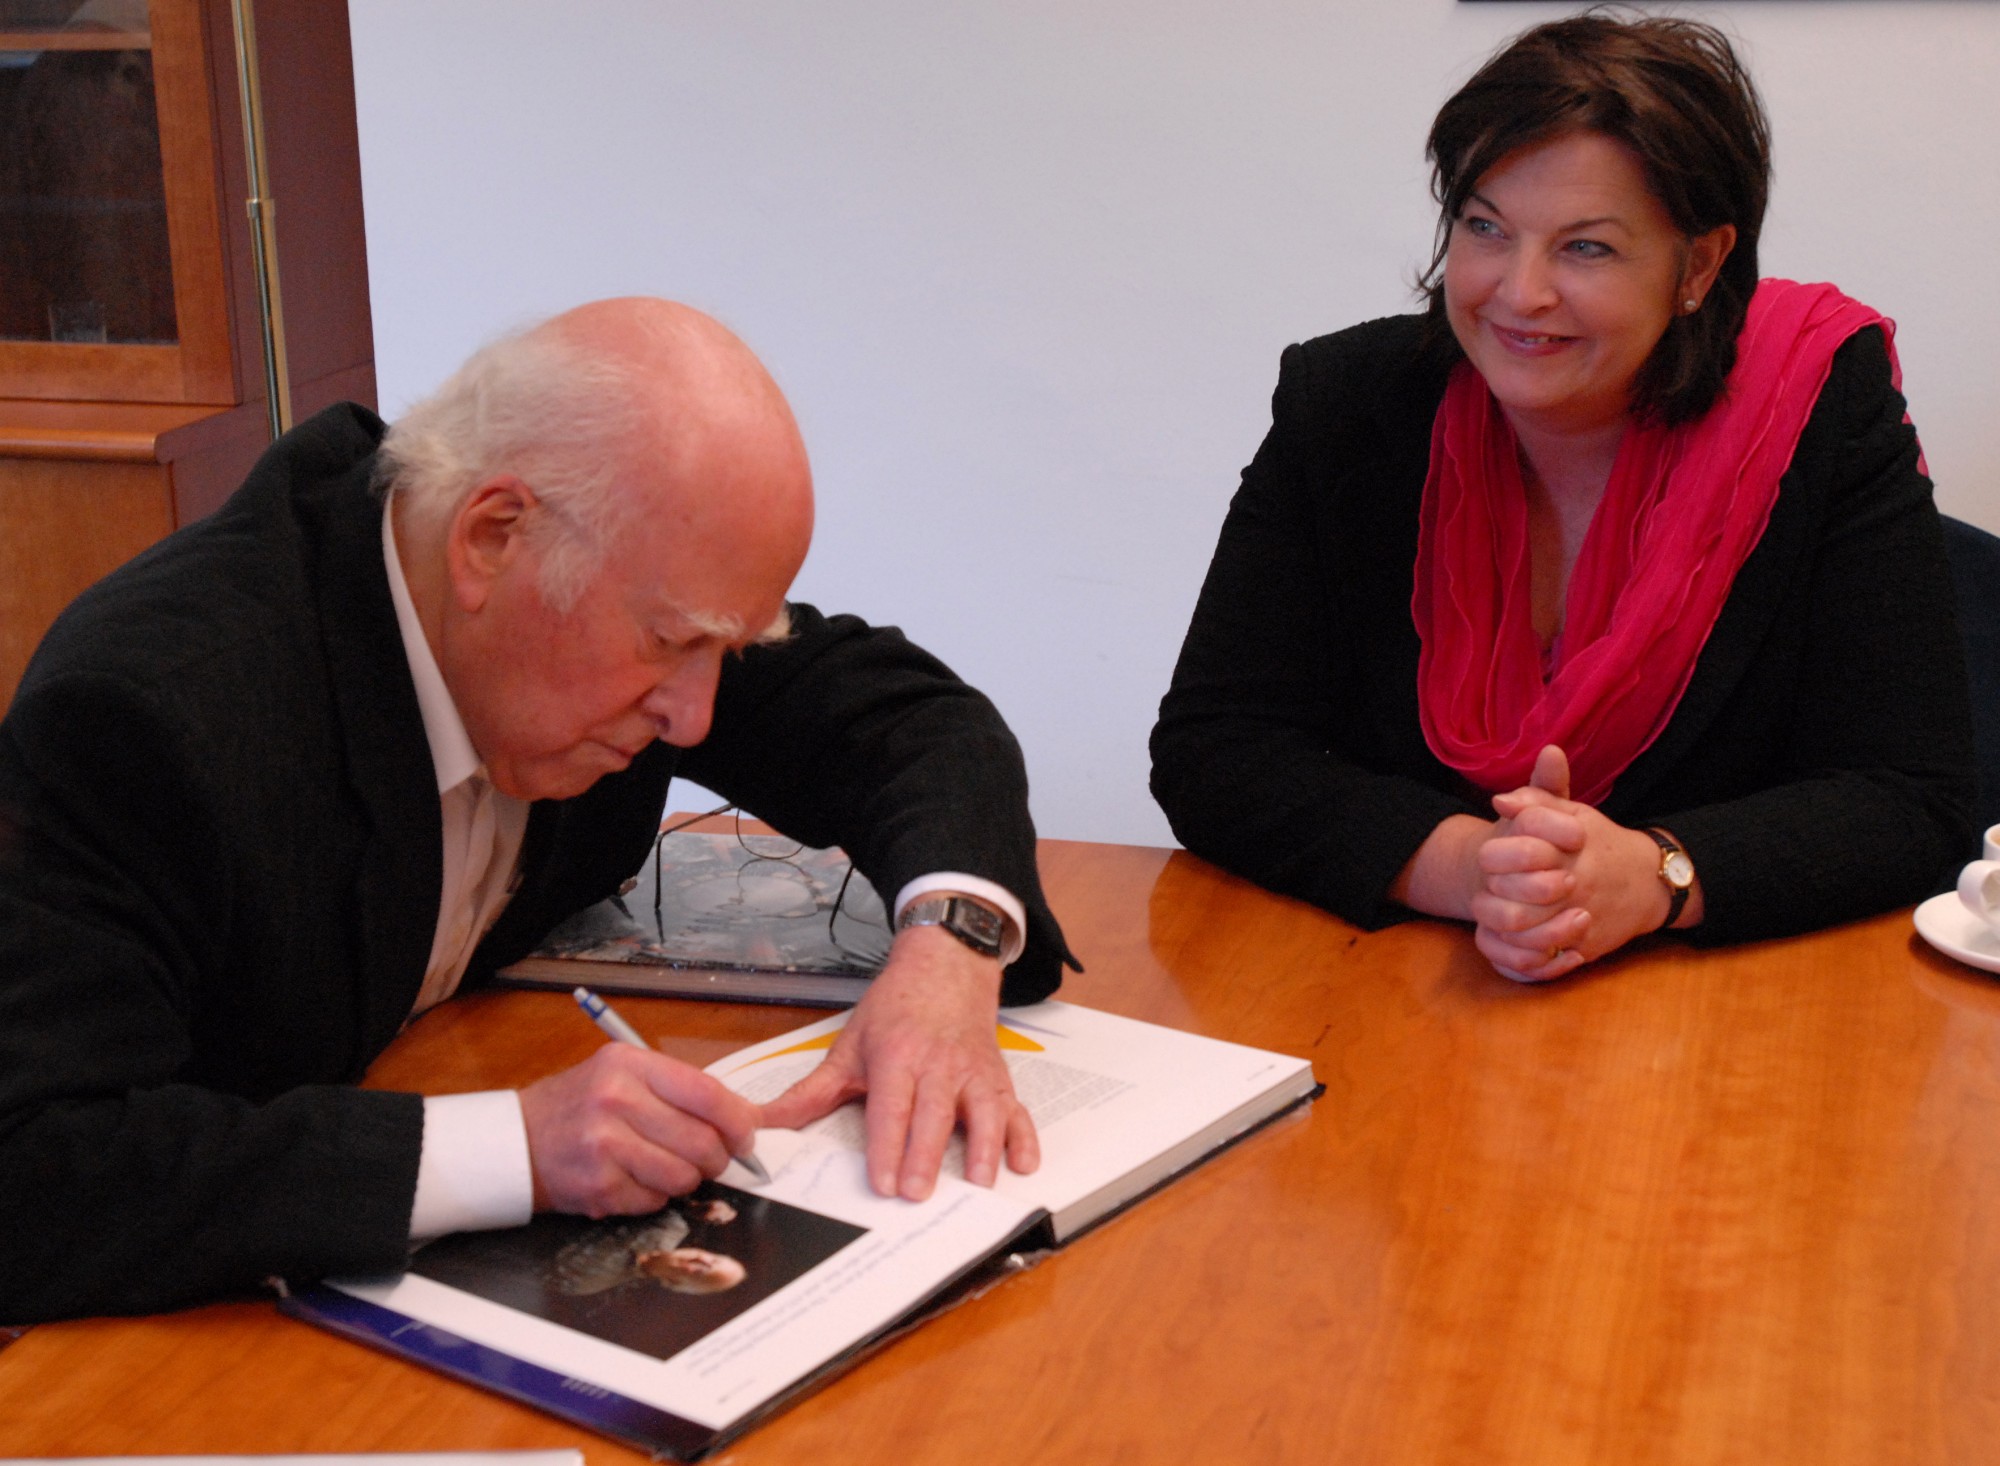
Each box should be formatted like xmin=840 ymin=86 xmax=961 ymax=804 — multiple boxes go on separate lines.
xmin=410 ymin=1090 xmax=534 ymax=1242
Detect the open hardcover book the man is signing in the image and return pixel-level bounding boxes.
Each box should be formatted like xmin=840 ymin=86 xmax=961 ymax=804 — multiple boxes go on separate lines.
xmin=280 ymin=1002 xmax=1318 ymax=1460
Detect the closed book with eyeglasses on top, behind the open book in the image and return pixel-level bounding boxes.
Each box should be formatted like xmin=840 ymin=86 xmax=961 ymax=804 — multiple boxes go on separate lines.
xmin=498 ymin=830 xmax=890 ymax=1008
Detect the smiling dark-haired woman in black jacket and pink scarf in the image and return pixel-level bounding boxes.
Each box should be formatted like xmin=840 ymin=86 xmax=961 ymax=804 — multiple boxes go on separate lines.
xmin=1152 ymin=12 xmax=1972 ymax=980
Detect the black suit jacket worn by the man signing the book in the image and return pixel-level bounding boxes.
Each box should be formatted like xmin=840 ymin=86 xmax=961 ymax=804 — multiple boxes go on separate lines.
xmin=0 ymin=406 xmax=1068 ymax=1322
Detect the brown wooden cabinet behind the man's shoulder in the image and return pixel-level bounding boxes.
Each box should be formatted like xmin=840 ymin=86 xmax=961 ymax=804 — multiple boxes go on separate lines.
xmin=0 ymin=0 xmax=374 ymax=706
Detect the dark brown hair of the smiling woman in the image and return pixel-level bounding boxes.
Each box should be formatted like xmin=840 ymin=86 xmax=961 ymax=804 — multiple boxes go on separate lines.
xmin=1418 ymin=10 xmax=1770 ymax=424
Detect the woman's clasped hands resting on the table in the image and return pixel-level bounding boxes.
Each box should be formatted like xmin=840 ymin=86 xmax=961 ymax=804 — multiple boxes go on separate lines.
xmin=1470 ymin=744 xmax=1700 ymax=982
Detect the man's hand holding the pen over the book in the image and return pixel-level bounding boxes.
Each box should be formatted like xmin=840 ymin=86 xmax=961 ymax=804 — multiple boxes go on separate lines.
xmin=520 ymin=1044 xmax=756 ymax=1216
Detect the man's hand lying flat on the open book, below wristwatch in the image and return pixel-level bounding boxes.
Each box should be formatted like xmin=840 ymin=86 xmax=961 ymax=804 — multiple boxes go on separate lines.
xmin=764 ymin=926 xmax=1042 ymax=1202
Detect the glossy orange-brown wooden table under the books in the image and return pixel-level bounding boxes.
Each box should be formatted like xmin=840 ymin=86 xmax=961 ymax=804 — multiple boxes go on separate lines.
xmin=0 ymin=842 xmax=2000 ymax=1466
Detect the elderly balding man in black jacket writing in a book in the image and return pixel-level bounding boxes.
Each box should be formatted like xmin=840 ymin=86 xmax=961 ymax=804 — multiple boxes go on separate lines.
xmin=0 ymin=300 xmax=1070 ymax=1322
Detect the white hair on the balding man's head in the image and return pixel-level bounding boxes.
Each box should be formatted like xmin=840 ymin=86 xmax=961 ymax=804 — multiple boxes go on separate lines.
xmin=376 ymin=318 xmax=662 ymax=612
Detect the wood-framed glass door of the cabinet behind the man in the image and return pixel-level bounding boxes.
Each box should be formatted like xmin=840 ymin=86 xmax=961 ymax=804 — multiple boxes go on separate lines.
xmin=0 ymin=0 xmax=238 ymax=404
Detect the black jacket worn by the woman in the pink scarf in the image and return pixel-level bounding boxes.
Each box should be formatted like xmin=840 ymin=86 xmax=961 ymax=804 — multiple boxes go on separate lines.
xmin=1152 ymin=316 xmax=1978 ymax=942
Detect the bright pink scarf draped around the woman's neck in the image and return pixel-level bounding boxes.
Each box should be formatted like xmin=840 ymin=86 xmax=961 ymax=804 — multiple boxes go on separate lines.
xmin=1410 ymin=280 xmax=1902 ymax=804
